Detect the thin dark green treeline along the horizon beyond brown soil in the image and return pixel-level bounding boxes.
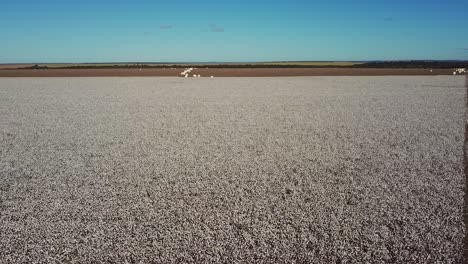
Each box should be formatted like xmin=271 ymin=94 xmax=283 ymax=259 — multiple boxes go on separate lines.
xmin=18 ymin=60 xmax=468 ymax=69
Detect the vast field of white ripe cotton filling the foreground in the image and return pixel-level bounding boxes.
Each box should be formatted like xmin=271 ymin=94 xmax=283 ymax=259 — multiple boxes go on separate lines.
xmin=0 ymin=76 xmax=466 ymax=263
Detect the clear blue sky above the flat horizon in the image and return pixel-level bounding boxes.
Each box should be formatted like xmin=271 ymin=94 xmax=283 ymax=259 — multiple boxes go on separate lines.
xmin=0 ymin=0 xmax=468 ymax=63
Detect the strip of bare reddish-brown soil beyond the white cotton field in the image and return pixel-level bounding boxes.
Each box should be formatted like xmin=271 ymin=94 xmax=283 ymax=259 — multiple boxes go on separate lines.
xmin=0 ymin=66 xmax=453 ymax=77
